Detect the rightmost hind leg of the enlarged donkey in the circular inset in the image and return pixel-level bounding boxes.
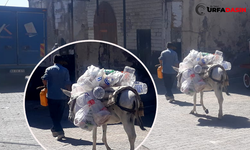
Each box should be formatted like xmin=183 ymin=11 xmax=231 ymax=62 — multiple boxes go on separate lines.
xmin=121 ymin=113 xmax=136 ymax=150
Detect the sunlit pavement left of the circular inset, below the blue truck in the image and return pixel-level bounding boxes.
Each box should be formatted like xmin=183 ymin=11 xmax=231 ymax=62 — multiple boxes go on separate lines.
xmin=0 ymin=90 xmax=42 ymax=150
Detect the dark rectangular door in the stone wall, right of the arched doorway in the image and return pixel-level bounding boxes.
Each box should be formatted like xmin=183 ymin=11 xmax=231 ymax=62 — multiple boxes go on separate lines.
xmin=137 ymin=29 xmax=151 ymax=67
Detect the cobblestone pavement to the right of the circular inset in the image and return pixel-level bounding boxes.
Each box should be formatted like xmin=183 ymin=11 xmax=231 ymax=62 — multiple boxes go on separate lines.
xmin=139 ymin=78 xmax=250 ymax=150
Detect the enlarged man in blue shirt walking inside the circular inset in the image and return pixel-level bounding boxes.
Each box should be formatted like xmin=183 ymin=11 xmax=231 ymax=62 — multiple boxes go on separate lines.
xmin=42 ymin=55 xmax=71 ymax=140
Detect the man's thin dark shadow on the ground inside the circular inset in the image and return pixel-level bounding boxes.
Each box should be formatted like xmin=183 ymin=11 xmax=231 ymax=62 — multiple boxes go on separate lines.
xmin=59 ymin=137 xmax=104 ymax=146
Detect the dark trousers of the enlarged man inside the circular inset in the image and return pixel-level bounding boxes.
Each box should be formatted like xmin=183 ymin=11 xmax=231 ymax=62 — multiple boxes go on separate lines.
xmin=48 ymin=98 xmax=66 ymax=133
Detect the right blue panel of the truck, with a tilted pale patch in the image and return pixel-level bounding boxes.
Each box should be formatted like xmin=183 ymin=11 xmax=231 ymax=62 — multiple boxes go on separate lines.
xmin=17 ymin=12 xmax=45 ymax=65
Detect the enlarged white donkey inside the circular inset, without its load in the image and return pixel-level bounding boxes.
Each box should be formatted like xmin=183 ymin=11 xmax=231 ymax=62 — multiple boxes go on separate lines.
xmin=63 ymin=87 xmax=146 ymax=150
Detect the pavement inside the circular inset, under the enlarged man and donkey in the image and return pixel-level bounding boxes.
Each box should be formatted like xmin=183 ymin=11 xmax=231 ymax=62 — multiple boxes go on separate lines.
xmin=27 ymin=98 xmax=153 ymax=150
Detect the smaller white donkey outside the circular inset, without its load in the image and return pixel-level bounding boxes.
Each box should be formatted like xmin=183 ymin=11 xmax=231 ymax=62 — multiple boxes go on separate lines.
xmin=173 ymin=65 xmax=229 ymax=119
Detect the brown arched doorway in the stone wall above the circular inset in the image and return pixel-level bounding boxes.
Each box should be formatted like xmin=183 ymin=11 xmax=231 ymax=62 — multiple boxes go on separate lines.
xmin=94 ymin=2 xmax=117 ymax=44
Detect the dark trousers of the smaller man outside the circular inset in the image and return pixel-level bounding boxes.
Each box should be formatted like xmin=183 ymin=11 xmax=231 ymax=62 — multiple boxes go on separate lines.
xmin=163 ymin=73 xmax=176 ymax=97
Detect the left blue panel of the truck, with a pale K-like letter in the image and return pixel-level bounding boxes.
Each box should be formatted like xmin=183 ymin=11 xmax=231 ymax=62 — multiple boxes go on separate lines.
xmin=0 ymin=11 xmax=17 ymax=65
